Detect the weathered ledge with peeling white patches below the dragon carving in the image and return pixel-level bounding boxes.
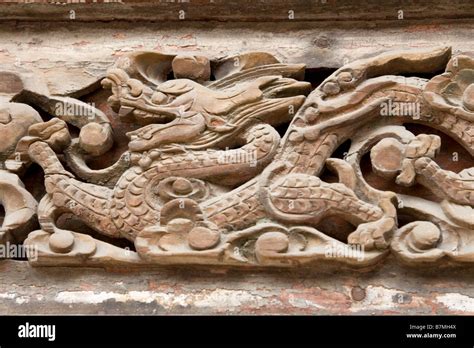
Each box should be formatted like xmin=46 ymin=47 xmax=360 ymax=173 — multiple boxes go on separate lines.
xmin=0 ymin=260 xmax=474 ymax=315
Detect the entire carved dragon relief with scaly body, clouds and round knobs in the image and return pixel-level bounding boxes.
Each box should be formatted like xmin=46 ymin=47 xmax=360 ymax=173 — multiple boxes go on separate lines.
xmin=0 ymin=48 xmax=474 ymax=267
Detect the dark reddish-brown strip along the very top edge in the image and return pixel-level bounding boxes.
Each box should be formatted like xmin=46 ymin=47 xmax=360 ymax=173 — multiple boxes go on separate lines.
xmin=0 ymin=0 xmax=474 ymax=22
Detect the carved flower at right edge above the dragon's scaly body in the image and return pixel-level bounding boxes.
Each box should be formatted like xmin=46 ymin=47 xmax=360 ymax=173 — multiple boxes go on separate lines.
xmin=423 ymin=56 xmax=474 ymax=121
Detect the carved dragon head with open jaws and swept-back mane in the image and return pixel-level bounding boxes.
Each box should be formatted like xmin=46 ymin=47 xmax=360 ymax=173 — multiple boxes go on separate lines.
xmin=102 ymin=52 xmax=311 ymax=151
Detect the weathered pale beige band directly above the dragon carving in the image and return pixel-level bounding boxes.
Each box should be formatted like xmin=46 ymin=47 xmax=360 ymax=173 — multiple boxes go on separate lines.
xmin=0 ymin=17 xmax=474 ymax=93
